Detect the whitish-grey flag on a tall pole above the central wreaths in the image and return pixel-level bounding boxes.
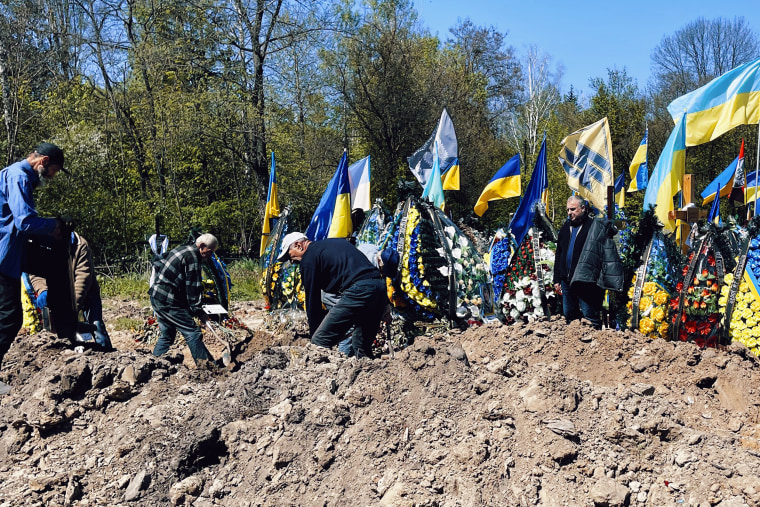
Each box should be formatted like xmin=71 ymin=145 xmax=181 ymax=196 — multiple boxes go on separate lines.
xmin=407 ymin=109 xmax=459 ymax=190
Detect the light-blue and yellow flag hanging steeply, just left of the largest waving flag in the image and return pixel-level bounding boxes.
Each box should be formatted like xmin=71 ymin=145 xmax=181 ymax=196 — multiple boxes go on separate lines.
xmin=644 ymin=114 xmax=686 ymax=232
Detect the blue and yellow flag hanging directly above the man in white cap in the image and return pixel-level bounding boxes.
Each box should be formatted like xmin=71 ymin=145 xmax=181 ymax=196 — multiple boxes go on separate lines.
xmin=304 ymin=151 xmax=353 ymax=241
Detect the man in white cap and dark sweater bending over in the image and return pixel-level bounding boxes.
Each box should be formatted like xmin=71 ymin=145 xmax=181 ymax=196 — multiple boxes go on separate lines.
xmin=278 ymin=232 xmax=387 ymax=358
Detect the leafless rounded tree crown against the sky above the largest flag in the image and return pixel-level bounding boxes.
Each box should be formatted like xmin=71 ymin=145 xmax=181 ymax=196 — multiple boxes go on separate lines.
xmin=652 ymin=17 xmax=760 ymax=99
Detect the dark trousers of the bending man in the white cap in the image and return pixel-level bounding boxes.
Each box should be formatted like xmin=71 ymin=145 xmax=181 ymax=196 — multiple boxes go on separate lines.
xmin=311 ymin=279 xmax=388 ymax=357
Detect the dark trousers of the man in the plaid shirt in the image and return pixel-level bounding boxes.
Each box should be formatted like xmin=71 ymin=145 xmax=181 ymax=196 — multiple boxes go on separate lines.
xmin=150 ymin=297 xmax=214 ymax=364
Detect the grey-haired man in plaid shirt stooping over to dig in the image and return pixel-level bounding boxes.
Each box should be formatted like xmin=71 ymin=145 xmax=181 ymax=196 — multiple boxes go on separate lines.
xmin=148 ymin=234 xmax=219 ymax=365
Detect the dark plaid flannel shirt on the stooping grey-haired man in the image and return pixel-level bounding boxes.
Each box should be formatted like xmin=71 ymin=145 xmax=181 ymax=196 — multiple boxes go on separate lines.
xmin=148 ymin=245 xmax=203 ymax=315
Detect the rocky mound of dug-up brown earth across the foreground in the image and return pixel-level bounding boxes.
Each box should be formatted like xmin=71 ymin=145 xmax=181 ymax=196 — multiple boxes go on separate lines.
xmin=0 ymin=301 xmax=760 ymax=507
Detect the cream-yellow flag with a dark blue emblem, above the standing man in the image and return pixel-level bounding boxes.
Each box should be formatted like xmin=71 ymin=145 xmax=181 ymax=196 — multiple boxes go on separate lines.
xmin=559 ymin=116 xmax=614 ymax=209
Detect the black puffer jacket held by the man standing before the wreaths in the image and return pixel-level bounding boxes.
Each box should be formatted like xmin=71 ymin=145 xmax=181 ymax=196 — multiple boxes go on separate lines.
xmin=570 ymin=218 xmax=623 ymax=291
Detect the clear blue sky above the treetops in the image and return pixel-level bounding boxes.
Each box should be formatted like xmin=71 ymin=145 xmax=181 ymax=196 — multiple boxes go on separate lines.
xmin=413 ymin=0 xmax=760 ymax=96
